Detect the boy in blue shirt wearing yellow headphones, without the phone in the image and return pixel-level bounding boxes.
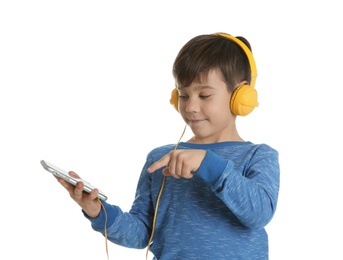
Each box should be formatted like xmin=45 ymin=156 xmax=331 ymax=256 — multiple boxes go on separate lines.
xmin=59 ymin=33 xmax=280 ymax=260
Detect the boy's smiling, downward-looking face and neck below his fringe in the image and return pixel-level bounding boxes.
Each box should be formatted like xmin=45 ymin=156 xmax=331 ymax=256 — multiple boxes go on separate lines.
xmin=179 ymin=70 xmax=241 ymax=143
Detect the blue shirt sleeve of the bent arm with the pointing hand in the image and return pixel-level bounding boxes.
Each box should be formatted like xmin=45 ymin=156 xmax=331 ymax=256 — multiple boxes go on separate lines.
xmin=195 ymin=145 xmax=280 ymax=228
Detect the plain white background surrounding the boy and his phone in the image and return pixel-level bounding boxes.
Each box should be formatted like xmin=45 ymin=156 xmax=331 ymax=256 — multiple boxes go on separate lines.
xmin=0 ymin=0 xmax=343 ymax=260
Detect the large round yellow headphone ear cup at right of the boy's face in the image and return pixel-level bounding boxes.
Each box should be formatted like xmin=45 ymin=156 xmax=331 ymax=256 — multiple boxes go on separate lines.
xmin=230 ymin=85 xmax=258 ymax=116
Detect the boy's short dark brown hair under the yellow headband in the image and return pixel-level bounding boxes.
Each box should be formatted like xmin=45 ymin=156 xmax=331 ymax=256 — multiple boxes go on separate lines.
xmin=173 ymin=34 xmax=251 ymax=92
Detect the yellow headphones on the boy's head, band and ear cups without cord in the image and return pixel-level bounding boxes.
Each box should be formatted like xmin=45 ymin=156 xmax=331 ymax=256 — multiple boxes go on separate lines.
xmin=170 ymin=33 xmax=258 ymax=116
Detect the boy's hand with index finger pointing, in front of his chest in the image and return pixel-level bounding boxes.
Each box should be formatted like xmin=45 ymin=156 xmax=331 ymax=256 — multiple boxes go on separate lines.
xmin=147 ymin=150 xmax=206 ymax=179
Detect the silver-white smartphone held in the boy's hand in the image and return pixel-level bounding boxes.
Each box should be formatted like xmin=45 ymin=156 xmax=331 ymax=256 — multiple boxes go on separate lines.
xmin=40 ymin=160 xmax=107 ymax=201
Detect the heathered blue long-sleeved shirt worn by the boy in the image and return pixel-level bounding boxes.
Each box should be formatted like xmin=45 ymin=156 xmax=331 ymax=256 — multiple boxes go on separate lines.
xmin=86 ymin=142 xmax=280 ymax=260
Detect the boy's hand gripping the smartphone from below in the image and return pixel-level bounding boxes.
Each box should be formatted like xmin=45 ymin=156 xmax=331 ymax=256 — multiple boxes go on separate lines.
xmin=56 ymin=171 xmax=101 ymax=218
